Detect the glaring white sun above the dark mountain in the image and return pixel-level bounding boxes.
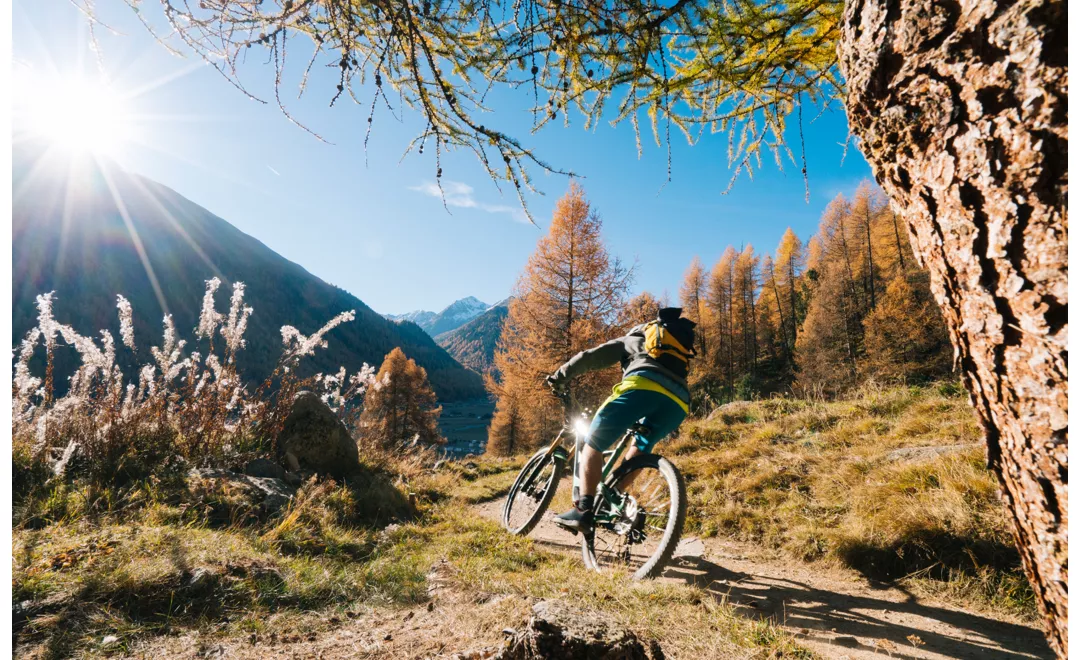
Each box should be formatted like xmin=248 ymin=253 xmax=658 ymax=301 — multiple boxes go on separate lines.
xmin=14 ymin=71 xmax=133 ymax=154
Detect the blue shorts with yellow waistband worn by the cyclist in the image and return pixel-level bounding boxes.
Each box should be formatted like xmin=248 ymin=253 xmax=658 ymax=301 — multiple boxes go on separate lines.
xmin=586 ymin=390 xmax=686 ymax=454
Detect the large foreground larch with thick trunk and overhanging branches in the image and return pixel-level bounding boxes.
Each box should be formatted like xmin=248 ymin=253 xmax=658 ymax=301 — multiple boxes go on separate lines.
xmin=105 ymin=0 xmax=1068 ymax=643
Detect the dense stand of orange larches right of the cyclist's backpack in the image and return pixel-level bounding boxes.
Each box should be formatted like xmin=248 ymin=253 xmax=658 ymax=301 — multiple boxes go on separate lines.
xmin=679 ymin=183 xmax=951 ymax=404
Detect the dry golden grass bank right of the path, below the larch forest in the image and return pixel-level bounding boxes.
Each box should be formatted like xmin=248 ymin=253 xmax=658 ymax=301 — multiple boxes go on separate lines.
xmin=664 ymin=385 xmax=1036 ymax=619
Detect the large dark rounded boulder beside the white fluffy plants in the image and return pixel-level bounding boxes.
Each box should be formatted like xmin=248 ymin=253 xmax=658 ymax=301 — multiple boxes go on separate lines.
xmin=278 ymin=391 xmax=360 ymax=479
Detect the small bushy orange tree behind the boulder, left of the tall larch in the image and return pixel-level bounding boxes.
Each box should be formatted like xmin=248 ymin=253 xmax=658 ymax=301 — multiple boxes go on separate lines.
xmin=360 ymin=348 xmax=443 ymax=449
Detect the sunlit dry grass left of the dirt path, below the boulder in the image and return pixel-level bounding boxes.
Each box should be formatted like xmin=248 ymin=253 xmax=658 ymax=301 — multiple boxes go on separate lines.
xmin=12 ymin=460 xmax=807 ymax=658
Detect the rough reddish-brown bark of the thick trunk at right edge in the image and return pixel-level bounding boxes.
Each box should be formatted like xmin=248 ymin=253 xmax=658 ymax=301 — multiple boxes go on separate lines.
xmin=839 ymin=0 xmax=1068 ymax=657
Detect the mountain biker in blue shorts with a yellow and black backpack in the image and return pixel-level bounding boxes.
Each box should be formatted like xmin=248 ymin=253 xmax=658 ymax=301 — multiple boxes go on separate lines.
xmin=548 ymin=307 xmax=696 ymax=534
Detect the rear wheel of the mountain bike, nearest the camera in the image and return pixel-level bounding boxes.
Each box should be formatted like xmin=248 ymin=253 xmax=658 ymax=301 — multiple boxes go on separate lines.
xmin=581 ymin=454 xmax=686 ymax=579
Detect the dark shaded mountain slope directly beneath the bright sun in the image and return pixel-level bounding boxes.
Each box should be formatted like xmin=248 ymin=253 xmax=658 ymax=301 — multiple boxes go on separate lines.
xmin=12 ymin=143 xmax=484 ymax=401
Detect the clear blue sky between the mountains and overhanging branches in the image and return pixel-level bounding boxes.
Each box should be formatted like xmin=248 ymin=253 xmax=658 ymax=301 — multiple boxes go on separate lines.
xmin=12 ymin=0 xmax=870 ymax=313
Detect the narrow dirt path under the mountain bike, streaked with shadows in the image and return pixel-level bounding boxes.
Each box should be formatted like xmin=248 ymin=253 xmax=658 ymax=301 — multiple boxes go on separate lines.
xmin=476 ymin=499 xmax=1053 ymax=660
